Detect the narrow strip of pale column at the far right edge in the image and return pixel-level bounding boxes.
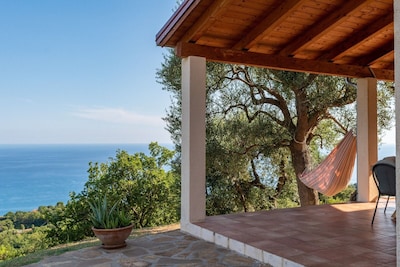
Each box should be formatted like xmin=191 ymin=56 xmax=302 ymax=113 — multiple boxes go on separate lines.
xmin=393 ymin=0 xmax=400 ymax=266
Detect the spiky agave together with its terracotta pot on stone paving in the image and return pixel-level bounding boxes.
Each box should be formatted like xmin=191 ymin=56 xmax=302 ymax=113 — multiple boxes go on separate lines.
xmin=89 ymin=197 xmax=133 ymax=249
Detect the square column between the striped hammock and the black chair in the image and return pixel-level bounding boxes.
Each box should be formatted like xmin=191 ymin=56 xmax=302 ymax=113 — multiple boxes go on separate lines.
xmin=357 ymin=78 xmax=378 ymax=202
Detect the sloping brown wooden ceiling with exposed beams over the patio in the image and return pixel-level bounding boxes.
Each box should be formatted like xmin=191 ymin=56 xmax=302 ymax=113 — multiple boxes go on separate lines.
xmin=156 ymin=0 xmax=394 ymax=80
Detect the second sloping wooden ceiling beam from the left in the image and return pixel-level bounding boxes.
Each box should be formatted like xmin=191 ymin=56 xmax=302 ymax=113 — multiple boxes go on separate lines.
xmin=232 ymin=0 xmax=304 ymax=50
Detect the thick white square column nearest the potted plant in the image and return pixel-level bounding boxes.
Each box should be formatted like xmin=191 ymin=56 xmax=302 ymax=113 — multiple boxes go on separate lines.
xmin=181 ymin=57 xmax=206 ymax=228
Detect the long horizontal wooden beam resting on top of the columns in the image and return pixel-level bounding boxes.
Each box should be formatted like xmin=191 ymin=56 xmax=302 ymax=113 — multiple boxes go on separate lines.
xmin=175 ymin=42 xmax=394 ymax=81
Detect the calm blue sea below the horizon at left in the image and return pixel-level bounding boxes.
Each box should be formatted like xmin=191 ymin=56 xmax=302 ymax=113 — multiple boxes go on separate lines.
xmin=0 ymin=144 xmax=172 ymax=216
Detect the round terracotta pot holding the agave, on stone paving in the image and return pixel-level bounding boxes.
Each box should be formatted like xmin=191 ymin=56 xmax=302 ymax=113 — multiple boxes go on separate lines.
xmin=92 ymin=225 xmax=133 ymax=249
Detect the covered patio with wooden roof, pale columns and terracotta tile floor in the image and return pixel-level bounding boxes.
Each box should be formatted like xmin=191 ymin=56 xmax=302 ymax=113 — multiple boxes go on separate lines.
xmin=156 ymin=0 xmax=400 ymax=266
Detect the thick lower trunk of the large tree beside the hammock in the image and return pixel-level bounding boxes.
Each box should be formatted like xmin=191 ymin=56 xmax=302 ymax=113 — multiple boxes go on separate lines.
xmin=290 ymin=142 xmax=319 ymax=206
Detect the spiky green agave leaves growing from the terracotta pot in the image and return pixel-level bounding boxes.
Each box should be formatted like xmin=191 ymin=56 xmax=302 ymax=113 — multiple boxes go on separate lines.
xmin=89 ymin=196 xmax=132 ymax=229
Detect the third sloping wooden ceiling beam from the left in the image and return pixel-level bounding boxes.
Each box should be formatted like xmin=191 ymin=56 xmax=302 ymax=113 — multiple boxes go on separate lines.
xmin=279 ymin=0 xmax=375 ymax=56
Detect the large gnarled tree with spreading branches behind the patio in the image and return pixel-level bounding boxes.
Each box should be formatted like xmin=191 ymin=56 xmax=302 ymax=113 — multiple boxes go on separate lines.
xmin=157 ymin=51 xmax=393 ymax=211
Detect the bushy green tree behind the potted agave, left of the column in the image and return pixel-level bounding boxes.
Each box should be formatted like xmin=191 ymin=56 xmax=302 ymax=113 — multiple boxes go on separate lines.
xmin=84 ymin=143 xmax=179 ymax=227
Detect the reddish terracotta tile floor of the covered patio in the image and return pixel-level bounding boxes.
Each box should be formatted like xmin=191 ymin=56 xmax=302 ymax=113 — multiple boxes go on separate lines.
xmin=196 ymin=202 xmax=396 ymax=267
